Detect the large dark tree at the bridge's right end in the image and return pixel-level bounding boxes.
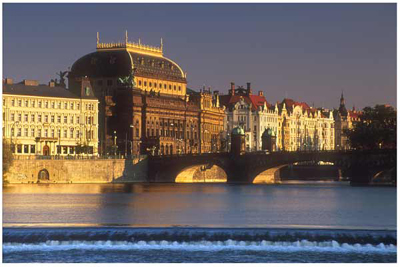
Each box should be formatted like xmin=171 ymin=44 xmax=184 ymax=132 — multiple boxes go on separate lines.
xmin=344 ymin=105 xmax=397 ymax=149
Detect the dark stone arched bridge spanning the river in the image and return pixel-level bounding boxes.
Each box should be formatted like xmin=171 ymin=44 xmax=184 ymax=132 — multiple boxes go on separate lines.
xmin=148 ymin=150 xmax=397 ymax=184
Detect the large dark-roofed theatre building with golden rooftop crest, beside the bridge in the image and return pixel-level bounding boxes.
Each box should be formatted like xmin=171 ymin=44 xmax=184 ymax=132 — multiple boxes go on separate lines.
xmin=68 ymin=33 xmax=224 ymax=155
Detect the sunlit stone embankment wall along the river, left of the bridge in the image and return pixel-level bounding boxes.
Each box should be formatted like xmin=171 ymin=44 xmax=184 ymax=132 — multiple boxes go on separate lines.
xmin=5 ymin=159 xmax=147 ymax=183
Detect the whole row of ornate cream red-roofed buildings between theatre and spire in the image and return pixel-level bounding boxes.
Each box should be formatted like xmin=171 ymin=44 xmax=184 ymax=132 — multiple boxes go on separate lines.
xmin=221 ymin=83 xmax=335 ymax=151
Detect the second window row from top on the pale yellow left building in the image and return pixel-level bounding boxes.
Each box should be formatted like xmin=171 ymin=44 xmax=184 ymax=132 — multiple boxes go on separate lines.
xmin=8 ymin=113 xmax=94 ymax=124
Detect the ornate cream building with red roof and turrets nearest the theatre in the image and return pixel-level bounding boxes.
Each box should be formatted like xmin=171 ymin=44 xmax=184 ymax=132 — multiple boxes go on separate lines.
xmin=220 ymin=83 xmax=278 ymax=151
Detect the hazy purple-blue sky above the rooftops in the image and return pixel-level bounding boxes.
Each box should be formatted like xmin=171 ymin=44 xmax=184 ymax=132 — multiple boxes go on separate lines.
xmin=3 ymin=4 xmax=396 ymax=108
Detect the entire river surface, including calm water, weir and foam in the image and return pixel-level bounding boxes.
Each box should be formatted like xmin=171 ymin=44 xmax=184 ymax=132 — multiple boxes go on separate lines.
xmin=3 ymin=182 xmax=397 ymax=262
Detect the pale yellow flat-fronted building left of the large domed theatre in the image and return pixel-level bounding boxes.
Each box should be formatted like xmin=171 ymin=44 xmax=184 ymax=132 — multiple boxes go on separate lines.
xmin=3 ymin=78 xmax=98 ymax=156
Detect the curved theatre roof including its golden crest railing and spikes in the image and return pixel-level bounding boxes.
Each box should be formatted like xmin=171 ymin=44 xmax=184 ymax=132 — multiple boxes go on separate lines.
xmin=69 ymin=30 xmax=186 ymax=83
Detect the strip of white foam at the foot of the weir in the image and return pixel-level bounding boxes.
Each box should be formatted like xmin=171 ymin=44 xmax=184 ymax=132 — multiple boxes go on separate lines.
xmin=3 ymin=240 xmax=397 ymax=253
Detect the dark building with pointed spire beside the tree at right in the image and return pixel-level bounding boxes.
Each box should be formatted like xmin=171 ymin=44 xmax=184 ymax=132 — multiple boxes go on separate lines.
xmin=334 ymin=92 xmax=361 ymax=149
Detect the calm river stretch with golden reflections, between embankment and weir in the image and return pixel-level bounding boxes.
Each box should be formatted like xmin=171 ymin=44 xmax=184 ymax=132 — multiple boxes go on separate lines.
xmin=3 ymin=183 xmax=396 ymax=230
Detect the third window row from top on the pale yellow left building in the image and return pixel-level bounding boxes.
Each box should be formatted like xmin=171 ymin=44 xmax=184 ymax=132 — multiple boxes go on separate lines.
xmin=9 ymin=128 xmax=94 ymax=139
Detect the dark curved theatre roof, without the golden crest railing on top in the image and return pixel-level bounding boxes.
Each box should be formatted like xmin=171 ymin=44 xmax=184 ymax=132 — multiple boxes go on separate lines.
xmin=69 ymin=49 xmax=186 ymax=82
